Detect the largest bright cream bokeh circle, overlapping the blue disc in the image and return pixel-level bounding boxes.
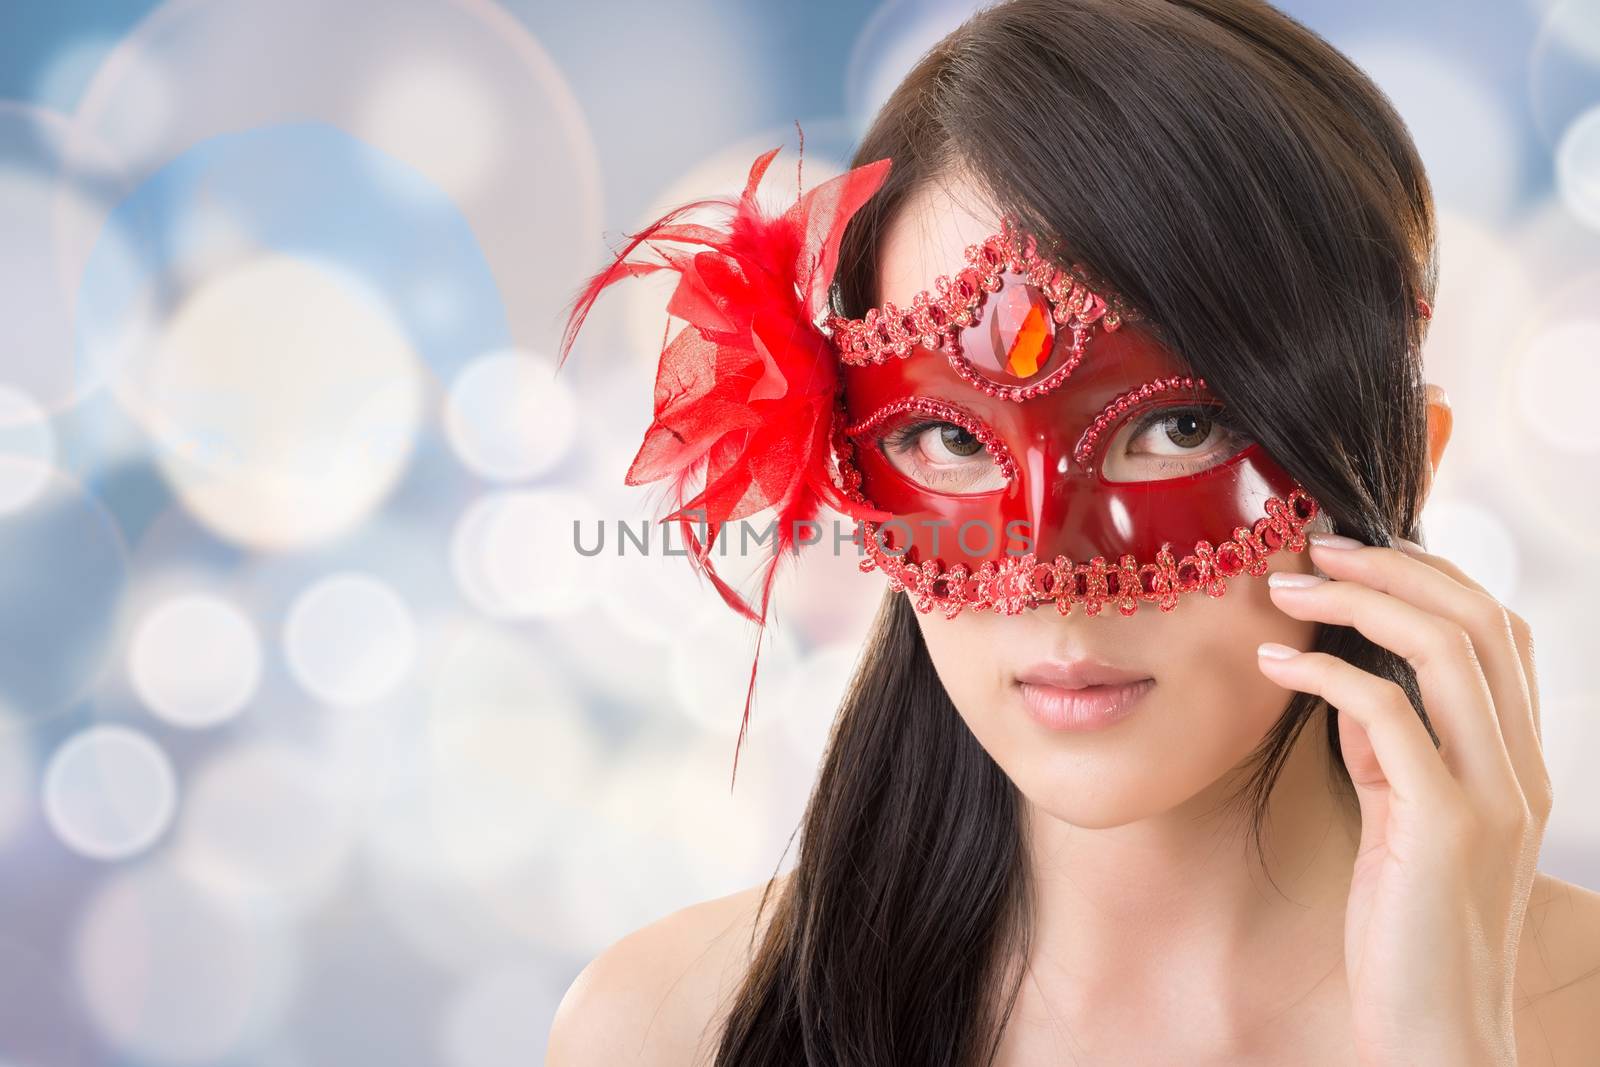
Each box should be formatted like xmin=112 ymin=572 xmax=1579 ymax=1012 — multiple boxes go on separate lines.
xmin=117 ymin=253 xmax=422 ymax=549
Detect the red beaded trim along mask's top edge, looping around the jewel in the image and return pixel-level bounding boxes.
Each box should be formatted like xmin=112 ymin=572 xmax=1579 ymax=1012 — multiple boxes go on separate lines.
xmin=822 ymin=218 xmax=1142 ymax=400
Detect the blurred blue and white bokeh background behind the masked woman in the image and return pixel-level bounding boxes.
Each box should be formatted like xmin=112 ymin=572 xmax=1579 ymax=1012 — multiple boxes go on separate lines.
xmin=0 ymin=0 xmax=1600 ymax=1067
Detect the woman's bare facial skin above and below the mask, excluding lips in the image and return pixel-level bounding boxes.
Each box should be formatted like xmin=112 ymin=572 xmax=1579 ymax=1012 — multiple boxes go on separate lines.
xmin=877 ymin=181 xmax=1320 ymax=827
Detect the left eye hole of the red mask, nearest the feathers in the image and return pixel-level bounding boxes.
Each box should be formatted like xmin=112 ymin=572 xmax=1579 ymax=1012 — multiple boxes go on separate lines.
xmin=846 ymin=398 xmax=1014 ymax=496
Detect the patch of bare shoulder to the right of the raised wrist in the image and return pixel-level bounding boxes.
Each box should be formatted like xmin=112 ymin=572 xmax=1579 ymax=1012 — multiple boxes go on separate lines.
xmin=1517 ymin=872 xmax=1600 ymax=1067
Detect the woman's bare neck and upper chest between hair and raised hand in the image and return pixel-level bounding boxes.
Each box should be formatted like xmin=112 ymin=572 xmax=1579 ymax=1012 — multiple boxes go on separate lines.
xmin=1027 ymin=713 xmax=1360 ymax=1033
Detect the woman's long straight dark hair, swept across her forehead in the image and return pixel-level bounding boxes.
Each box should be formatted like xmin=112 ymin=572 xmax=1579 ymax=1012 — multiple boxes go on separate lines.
xmin=717 ymin=0 xmax=1437 ymax=1067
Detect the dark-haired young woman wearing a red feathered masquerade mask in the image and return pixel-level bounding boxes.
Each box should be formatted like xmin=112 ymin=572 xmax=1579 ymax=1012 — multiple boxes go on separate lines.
xmin=547 ymin=0 xmax=1600 ymax=1067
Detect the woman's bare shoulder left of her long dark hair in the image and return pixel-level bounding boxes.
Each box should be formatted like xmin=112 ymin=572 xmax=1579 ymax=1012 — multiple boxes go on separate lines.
xmin=544 ymin=875 xmax=789 ymax=1067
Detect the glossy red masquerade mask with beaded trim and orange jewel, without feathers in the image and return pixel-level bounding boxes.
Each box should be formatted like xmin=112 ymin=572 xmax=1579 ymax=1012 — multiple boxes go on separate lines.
xmin=827 ymin=217 xmax=1317 ymax=614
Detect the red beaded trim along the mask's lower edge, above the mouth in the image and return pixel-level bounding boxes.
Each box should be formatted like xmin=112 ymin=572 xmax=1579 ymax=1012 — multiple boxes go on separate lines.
xmin=834 ymin=398 xmax=1320 ymax=619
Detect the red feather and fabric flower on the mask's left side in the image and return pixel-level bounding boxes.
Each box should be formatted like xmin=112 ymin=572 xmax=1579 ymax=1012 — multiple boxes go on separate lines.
xmin=557 ymin=131 xmax=890 ymax=776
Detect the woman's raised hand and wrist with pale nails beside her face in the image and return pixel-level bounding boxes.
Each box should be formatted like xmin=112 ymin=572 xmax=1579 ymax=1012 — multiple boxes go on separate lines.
xmin=1259 ymin=534 xmax=1550 ymax=1065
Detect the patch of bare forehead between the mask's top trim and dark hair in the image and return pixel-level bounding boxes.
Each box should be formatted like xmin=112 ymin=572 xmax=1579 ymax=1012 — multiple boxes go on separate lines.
xmin=874 ymin=178 xmax=1000 ymax=307
